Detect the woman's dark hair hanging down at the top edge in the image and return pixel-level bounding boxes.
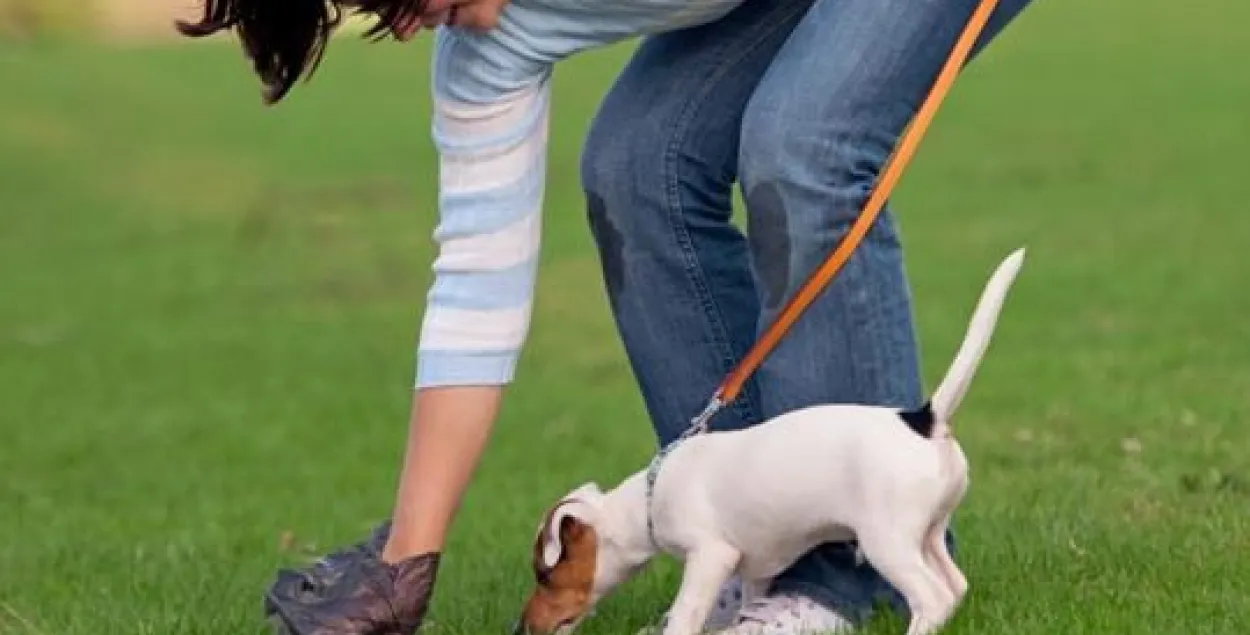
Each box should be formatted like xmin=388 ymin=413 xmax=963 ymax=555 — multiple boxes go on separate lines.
xmin=176 ymin=0 xmax=426 ymax=105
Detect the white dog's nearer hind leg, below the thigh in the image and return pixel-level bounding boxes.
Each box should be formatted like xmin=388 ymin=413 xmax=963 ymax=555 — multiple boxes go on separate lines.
xmin=859 ymin=528 xmax=951 ymax=635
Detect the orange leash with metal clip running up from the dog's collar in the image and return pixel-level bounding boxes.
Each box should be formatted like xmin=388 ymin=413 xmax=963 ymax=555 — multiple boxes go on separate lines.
xmin=683 ymin=0 xmax=999 ymax=436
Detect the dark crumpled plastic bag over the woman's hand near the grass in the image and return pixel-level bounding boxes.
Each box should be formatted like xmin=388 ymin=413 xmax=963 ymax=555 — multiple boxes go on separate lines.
xmin=264 ymin=525 xmax=439 ymax=635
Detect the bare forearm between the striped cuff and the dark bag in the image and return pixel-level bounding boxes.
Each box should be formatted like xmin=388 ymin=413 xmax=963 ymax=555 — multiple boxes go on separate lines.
xmin=383 ymin=386 xmax=503 ymax=563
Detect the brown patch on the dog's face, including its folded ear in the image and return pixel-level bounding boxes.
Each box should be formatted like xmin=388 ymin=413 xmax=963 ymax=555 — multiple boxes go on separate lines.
xmin=516 ymin=499 xmax=599 ymax=635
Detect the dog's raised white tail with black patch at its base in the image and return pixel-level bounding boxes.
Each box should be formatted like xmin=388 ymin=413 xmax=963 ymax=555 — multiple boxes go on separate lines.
xmin=903 ymin=248 xmax=1025 ymax=436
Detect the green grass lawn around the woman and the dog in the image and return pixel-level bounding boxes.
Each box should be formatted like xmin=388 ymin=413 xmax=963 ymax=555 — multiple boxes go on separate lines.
xmin=0 ymin=0 xmax=1250 ymax=635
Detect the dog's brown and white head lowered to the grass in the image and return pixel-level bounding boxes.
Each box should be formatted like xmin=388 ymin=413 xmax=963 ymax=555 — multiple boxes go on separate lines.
xmin=515 ymin=483 xmax=640 ymax=635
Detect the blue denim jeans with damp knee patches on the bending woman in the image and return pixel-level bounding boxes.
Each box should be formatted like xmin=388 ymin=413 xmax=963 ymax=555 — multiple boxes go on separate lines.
xmin=583 ymin=0 xmax=1029 ymax=621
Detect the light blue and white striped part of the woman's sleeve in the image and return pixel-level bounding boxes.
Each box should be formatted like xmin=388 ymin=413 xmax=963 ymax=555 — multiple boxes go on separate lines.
xmin=416 ymin=29 xmax=550 ymax=388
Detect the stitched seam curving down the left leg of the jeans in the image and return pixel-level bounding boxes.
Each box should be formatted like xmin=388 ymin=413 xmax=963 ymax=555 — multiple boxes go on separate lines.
xmin=664 ymin=1 xmax=798 ymax=421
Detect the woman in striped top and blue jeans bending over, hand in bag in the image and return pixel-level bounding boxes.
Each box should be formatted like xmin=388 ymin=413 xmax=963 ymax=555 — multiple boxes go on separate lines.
xmin=184 ymin=0 xmax=1028 ymax=635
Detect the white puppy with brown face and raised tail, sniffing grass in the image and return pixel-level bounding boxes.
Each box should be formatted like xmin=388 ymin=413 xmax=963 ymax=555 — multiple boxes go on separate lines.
xmin=515 ymin=248 xmax=1025 ymax=635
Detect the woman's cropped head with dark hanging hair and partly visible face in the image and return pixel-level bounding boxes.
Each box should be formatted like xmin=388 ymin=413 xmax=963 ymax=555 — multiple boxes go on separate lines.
xmin=175 ymin=0 xmax=508 ymax=105
